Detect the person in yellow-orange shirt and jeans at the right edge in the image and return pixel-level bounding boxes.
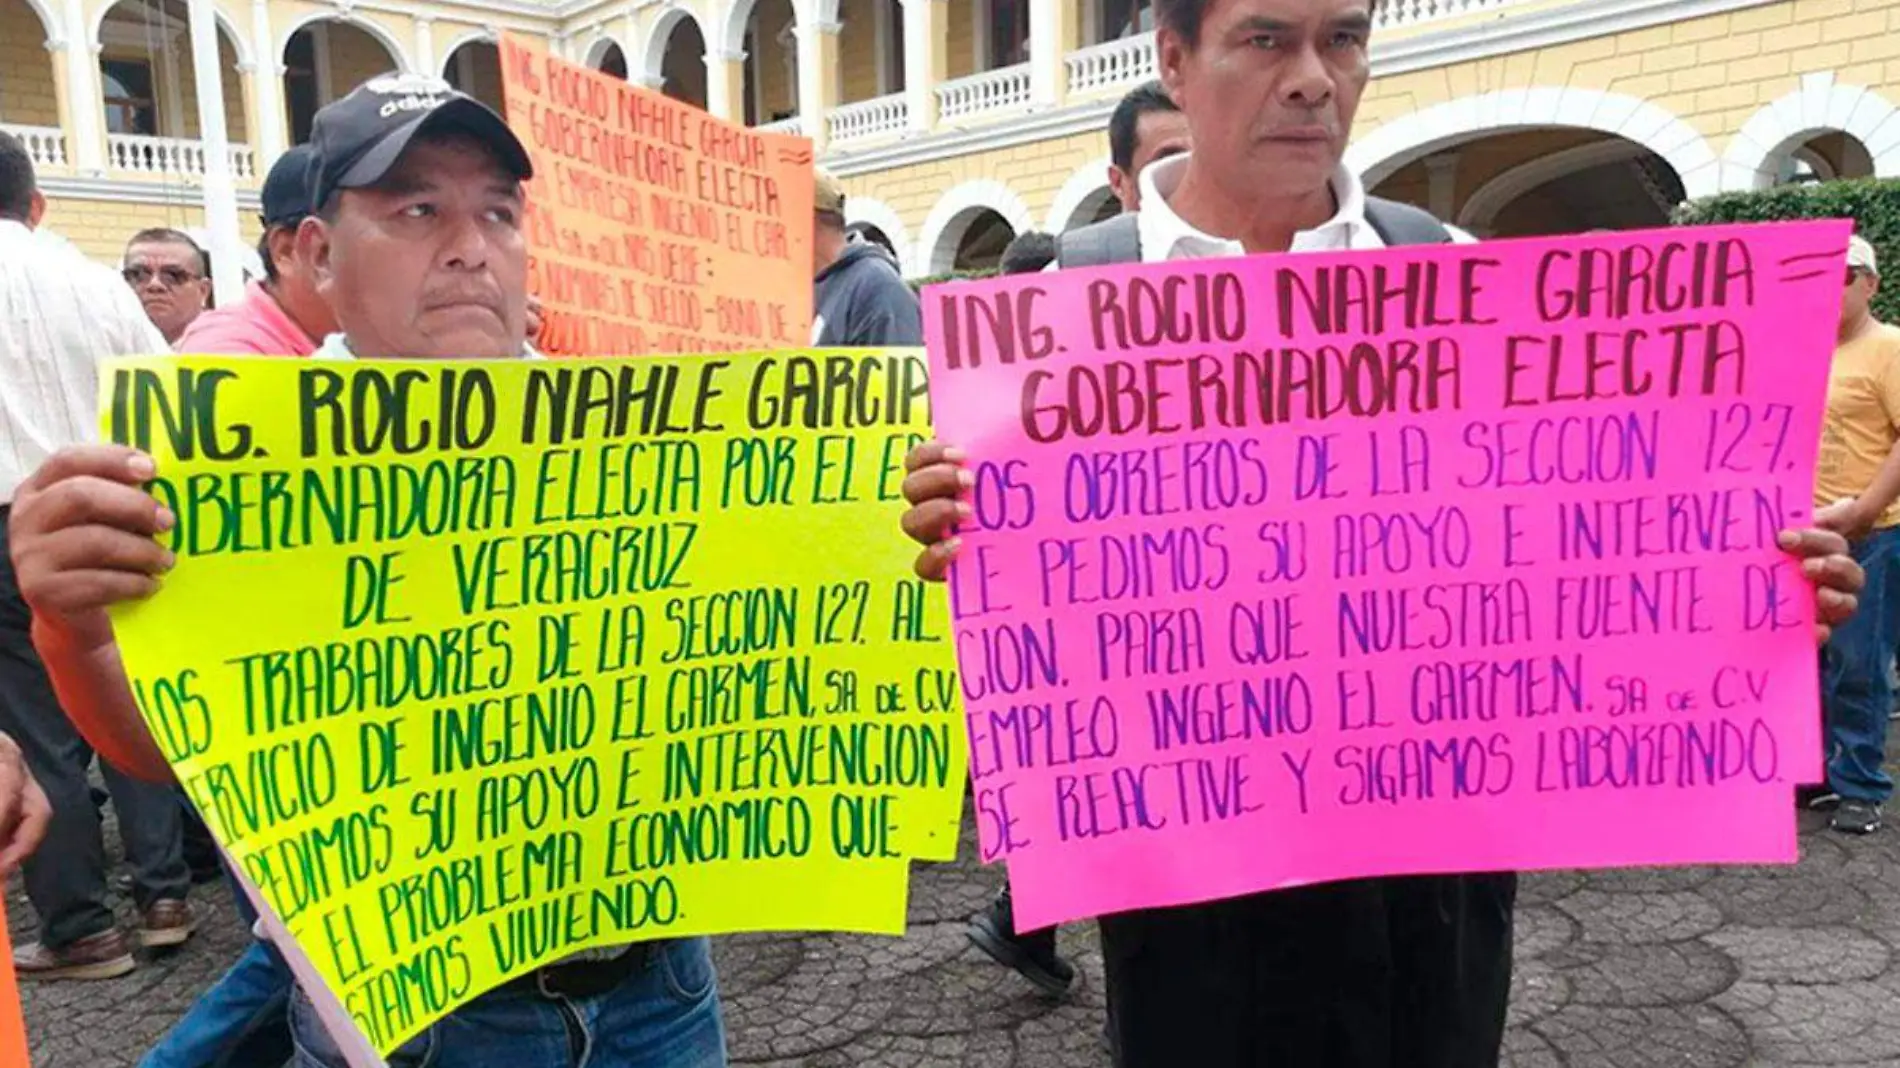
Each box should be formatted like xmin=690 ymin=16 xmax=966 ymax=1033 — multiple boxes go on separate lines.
xmin=1815 ymin=236 xmax=1900 ymax=834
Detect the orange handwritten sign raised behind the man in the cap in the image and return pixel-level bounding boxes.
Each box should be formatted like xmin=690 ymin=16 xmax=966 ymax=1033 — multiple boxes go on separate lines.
xmin=502 ymin=36 xmax=813 ymax=355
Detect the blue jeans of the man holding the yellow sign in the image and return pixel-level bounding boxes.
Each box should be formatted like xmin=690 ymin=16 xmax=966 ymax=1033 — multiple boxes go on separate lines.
xmin=291 ymin=939 xmax=726 ymax=1068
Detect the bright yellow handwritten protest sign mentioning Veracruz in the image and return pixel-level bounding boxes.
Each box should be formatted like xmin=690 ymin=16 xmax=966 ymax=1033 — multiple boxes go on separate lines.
xmin=101 ymin=350 xmax=965 ymax=1051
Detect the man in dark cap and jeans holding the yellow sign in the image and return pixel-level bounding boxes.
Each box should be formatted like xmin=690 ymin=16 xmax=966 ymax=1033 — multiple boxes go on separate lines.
xmin=13 ymin=74 xmax=726 ymax=1068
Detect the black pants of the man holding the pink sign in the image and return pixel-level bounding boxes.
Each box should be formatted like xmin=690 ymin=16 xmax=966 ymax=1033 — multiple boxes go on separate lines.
xmin=1100 ymin=874 xmax=1518 ymax=1068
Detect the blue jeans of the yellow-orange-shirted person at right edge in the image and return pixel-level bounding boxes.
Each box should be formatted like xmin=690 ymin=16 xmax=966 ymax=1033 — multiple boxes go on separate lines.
xmin=1820 ymin=526 xmax=1900 ymax=804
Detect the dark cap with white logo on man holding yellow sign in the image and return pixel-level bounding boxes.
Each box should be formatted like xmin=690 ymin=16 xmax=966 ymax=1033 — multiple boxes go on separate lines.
xmin=310 ymin=74 xmax=534 ymax=207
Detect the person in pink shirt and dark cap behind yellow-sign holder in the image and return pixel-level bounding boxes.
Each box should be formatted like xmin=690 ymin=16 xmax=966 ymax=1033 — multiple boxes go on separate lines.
xmin=173 ymin=144 xmax=336 ymax=355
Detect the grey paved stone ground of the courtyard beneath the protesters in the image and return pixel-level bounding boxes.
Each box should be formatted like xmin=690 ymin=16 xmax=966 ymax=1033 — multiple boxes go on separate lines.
xmin=6 ymin=798 xmax=1900 ymax=1068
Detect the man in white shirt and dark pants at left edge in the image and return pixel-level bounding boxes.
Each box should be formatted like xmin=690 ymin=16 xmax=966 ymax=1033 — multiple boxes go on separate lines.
xmin=0 ymin=133 xmax=192 ymax=979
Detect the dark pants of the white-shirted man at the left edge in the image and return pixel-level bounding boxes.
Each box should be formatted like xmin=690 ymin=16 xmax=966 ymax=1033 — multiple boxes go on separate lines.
xmin=0 ymin=507 xmax=190 ymax=948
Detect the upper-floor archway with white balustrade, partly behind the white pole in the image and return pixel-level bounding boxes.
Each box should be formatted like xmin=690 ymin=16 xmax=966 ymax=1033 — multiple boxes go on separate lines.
xmin=97 ymin=0 xmax=253 ymax=177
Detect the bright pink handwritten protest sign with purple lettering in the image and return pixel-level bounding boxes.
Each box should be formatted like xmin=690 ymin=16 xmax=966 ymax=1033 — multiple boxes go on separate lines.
xmin=925 ymin=222 xmax=1849 ymax=929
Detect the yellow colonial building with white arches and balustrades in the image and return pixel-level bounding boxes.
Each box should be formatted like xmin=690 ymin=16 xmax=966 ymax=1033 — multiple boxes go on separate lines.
xmin=0 ymin=0 xmax=1900 ymax=276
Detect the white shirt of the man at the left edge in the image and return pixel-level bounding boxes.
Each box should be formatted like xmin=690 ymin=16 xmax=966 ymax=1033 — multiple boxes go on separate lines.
xmin=0 ymin=219 xmax=171 ymax=504
